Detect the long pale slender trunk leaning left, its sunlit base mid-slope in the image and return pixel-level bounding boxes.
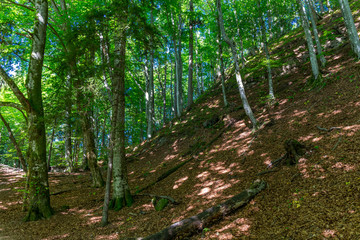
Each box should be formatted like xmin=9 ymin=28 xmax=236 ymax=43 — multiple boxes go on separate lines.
xmin=216 ymin=0 xmax=258 ymax=129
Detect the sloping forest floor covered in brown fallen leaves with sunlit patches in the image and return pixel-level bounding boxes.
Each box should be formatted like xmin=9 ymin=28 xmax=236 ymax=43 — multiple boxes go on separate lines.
xmin=0 ymin=5 xmax=360 ymax=240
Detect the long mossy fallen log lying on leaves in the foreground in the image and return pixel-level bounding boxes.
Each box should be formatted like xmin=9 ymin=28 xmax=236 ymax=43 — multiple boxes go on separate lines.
xmin=133 ymin=179 xmax=266 ymax=240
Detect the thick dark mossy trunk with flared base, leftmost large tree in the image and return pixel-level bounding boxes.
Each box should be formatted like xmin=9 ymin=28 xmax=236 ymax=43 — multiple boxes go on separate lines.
xmin=25 ymin=0 xmax=53 ymax=221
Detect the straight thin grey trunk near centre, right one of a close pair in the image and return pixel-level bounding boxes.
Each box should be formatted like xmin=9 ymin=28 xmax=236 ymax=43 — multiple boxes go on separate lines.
xmin=187 ymin=0 xmax=194 ymax=109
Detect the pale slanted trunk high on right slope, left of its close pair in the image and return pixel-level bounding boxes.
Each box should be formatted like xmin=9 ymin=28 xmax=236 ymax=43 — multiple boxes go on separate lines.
xmin=296 ymin=0 xmax=320 ymax=80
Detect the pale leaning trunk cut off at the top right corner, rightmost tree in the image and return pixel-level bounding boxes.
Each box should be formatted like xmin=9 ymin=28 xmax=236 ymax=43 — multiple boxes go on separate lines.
xmin=339 ymin=0 xmax=360 ymax=59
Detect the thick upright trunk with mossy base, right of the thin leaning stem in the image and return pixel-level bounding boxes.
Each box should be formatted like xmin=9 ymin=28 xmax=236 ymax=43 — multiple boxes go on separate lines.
xmin=110 ymin=1 xmax=133 ymax=210
